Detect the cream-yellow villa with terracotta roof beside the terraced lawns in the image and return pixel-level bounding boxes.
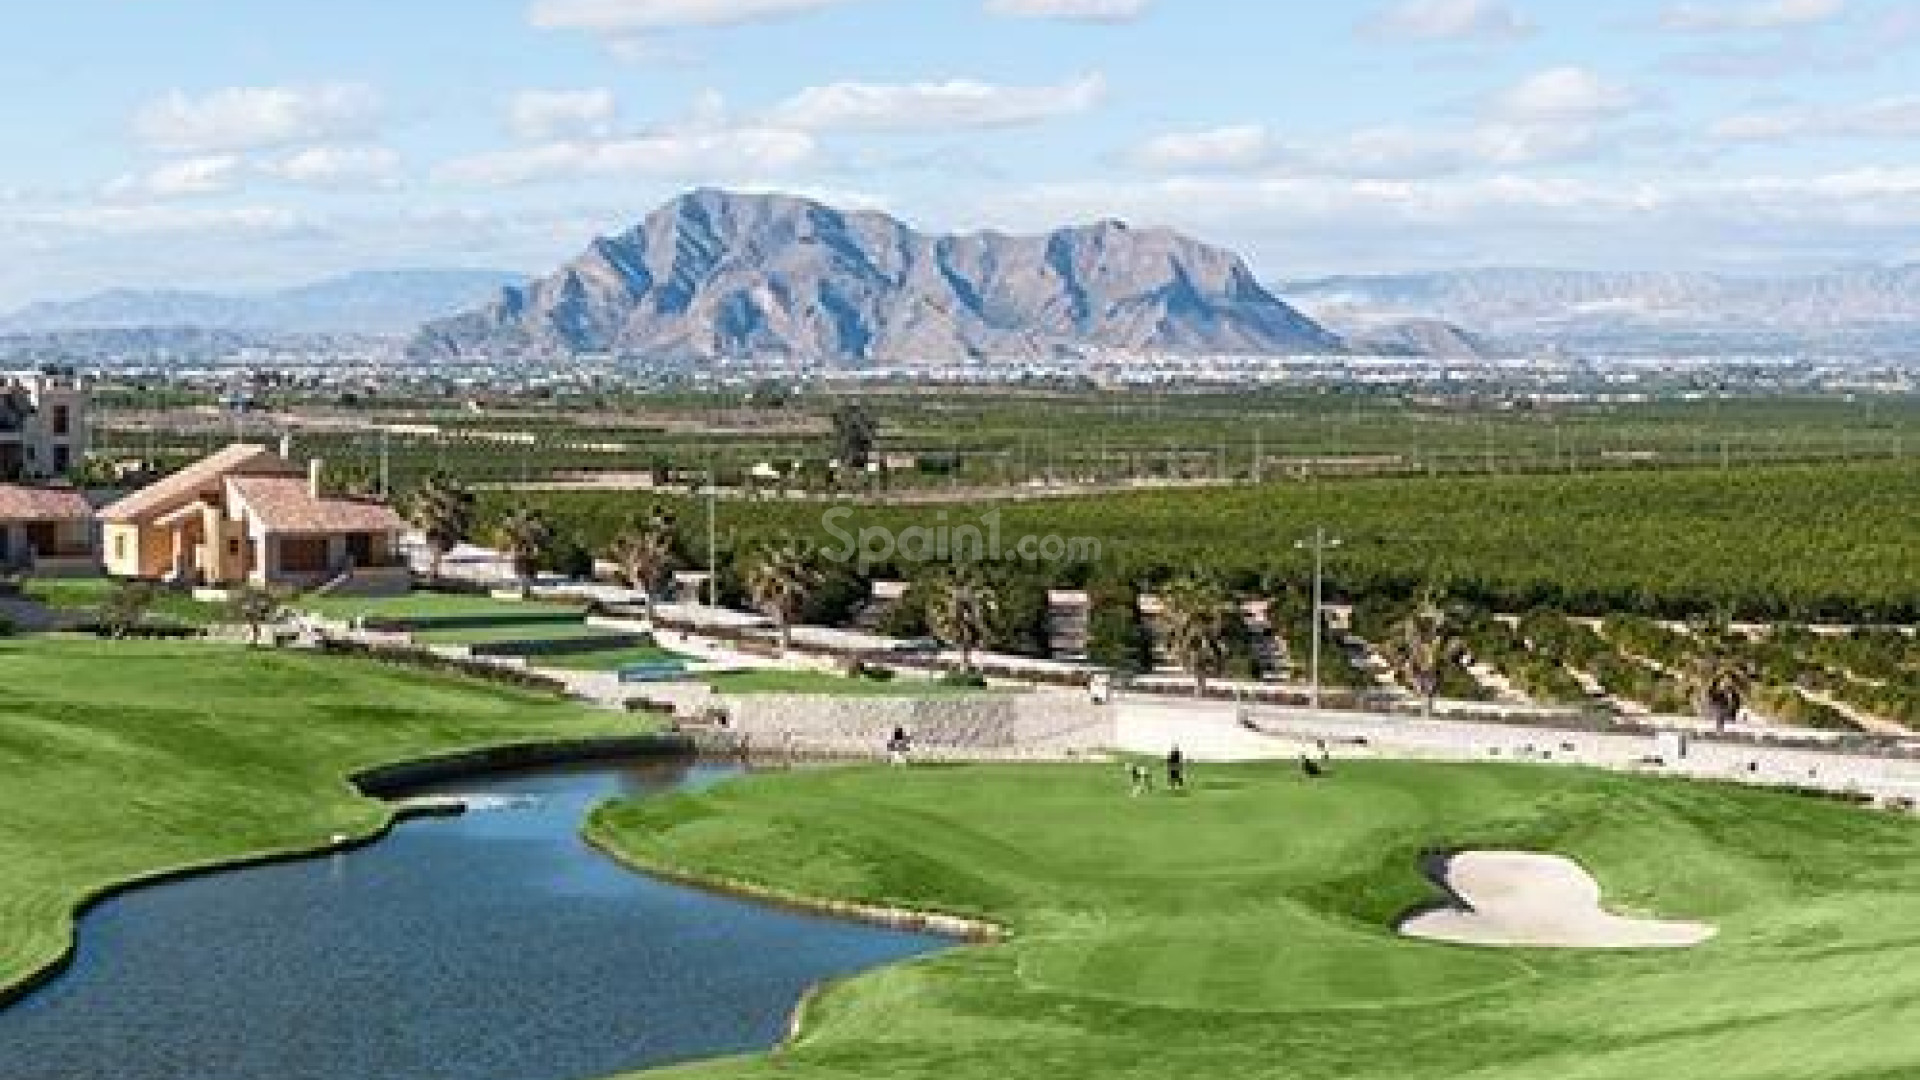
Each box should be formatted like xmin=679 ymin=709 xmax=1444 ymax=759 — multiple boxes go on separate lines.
xmin=100 ymin=444 xmax=411 ymax=594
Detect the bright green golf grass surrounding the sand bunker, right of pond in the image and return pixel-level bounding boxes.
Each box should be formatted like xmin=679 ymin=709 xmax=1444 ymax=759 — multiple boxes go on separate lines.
xmin=593 ymin=763 xmax=1920 ymax=1080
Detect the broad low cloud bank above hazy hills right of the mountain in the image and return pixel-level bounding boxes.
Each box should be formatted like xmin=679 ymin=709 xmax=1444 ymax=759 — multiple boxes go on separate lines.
xmin=975 ymin=169 xmax=1920 ymax=277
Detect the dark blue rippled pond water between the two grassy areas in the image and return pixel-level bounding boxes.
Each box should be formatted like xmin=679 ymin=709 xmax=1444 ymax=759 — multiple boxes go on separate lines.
xmin=0 ymin=763 xmax=945 ymax=1080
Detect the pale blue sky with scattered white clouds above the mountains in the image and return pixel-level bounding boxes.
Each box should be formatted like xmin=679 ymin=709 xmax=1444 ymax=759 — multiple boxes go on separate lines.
xmin=0 ymin=0 xmax=1920 ymax=309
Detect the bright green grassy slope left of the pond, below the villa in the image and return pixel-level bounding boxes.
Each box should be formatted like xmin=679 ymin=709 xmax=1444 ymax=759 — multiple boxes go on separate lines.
xmin=0 ymin=640 xmax=634 ymax=986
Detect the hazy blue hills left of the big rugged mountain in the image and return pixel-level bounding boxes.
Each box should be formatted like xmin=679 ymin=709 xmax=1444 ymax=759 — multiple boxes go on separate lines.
xmin=0 ymin=271 xmax=526 ymax=334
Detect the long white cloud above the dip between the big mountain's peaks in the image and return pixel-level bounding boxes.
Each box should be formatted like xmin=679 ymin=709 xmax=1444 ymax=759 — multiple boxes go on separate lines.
xmin=768 ymin=75 xmax=1106 ymax=133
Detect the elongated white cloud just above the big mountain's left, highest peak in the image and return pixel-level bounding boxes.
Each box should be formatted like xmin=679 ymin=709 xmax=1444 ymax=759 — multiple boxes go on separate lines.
xmin=438 ymin=127 xmax=816 ymax=186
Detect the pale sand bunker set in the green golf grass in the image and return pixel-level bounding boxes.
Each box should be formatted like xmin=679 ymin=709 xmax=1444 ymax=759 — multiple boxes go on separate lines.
xmin=1400 ymin=851 xmax=1715 ymax=949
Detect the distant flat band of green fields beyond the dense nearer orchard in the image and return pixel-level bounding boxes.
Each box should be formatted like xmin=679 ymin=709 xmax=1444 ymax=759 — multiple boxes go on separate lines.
xmin=100 ymin=386 xmax=1920 ymax=492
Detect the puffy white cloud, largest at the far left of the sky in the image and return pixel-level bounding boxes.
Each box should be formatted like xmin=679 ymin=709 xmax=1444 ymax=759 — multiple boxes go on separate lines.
xmin=134 ymin=83 xmax=380 ymax=154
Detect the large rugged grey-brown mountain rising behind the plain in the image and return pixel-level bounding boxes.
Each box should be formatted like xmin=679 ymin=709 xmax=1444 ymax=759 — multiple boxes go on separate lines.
xmin=413 ymin=190 xmax=1340 ymax=365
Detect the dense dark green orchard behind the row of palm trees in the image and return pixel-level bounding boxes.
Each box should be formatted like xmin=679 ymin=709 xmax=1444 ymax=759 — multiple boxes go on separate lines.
xmin=484 ymin=461 xmax=1920 ymax=623
